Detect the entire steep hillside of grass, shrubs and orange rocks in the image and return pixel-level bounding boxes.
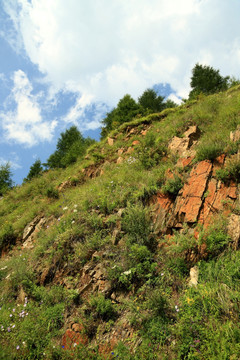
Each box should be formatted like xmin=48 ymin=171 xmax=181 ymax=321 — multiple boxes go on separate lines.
xmin=0 ymin=86 xmax=240 ymax=360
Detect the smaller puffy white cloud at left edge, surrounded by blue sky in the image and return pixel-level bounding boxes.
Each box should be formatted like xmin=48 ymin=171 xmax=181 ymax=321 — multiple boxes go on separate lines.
xmin=0 ymin=70 xmax=57 ymax=146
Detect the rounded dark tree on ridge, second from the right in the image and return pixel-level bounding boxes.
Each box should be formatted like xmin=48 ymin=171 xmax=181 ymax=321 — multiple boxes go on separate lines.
xmin=138 ymin=89 xmax=165 ymax=112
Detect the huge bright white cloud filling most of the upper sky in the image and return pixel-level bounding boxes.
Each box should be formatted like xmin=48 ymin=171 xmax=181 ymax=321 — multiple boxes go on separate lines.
xmin=4 ymin=0 xmax=240 ymax=110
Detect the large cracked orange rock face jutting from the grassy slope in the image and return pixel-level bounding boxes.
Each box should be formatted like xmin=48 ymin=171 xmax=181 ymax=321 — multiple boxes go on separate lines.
xmin=153 ymin=155 xmax=240 ymax=236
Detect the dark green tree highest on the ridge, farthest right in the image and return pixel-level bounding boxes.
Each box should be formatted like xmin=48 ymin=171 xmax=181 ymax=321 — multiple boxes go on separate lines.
xmin=189 ymin=64 xmax=229 ymax=99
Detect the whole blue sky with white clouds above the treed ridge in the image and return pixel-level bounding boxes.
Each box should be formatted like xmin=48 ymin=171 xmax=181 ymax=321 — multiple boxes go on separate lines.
xmin=0 ymin=0 xmax=240 ymax=183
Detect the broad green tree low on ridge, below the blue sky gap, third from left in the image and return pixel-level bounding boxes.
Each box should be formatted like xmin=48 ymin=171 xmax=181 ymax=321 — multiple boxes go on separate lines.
xmin=44 ymin=126 xmax=95 ymax=169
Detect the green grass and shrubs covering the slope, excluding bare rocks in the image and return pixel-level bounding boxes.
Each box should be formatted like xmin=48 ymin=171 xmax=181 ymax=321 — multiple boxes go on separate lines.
xmin=0 ymin=88 xmax=240 ymax=359
